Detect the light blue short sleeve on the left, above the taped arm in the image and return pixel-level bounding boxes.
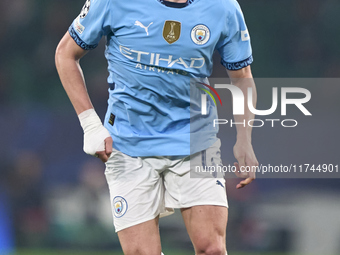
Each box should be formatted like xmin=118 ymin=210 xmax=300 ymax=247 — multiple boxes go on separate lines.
xmin=68 ymin=0 xmax=111 ymax=50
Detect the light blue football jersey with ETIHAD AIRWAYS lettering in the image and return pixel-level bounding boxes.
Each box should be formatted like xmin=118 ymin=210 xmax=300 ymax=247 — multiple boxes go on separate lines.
xmin=69 ymin=0 xmax=253 ymax=156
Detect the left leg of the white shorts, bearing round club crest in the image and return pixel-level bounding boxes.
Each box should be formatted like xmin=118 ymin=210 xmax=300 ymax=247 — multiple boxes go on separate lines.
xmin=105 ymin=147 xmax=164 ymax=232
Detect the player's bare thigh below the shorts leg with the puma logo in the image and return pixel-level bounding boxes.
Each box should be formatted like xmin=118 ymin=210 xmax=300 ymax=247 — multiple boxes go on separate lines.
xmin=181 ymin=205 xmax=228 ymax=254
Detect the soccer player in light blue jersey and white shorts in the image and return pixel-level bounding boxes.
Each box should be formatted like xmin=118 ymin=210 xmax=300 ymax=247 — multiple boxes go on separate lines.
xmin=56 ymin=0 xmax=258 ymax=255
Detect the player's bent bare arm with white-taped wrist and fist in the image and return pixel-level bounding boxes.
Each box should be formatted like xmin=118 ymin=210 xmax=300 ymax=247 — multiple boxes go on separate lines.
xmin=55 ymin=32 xmax=112 ymax=162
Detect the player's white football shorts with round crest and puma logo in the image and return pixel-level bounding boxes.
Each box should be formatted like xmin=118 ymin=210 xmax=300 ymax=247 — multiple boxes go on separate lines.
xmin=105 ymin=140 xmax=228 ymax=232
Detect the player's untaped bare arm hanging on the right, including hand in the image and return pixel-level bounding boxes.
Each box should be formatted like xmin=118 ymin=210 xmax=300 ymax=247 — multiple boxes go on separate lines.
xmin=228 ymin=66 xmax=258 ymax=189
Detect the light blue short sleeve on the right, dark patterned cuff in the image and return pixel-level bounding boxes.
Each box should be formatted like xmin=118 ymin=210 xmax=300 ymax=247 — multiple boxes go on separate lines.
xmin=217 ymin=0 xmax=253 ymax=70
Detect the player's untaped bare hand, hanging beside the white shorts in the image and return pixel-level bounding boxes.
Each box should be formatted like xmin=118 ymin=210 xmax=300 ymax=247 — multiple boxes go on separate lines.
xmin=234 ymin=139 xmax=259 ymax=189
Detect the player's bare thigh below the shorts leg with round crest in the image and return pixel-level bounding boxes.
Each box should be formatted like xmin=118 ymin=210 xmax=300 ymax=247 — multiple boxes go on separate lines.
xmin=118 ymin=217 xmax=161 ymax=255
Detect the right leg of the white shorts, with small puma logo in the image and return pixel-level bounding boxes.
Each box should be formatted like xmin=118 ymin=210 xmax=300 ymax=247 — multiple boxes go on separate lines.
xmin=163 ymin=140 xmax=228 ymax=208
